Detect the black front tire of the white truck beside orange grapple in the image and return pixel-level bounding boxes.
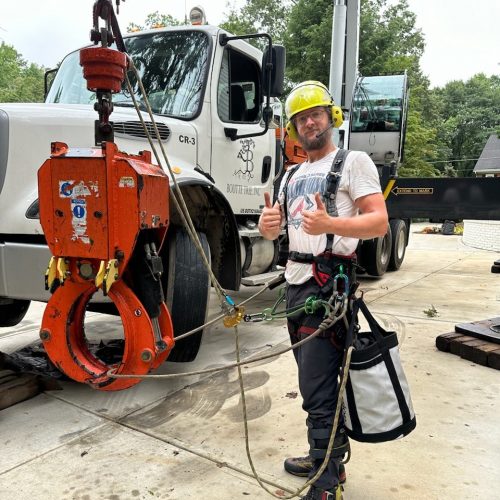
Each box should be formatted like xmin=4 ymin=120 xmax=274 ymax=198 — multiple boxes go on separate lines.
xmin=163 ymin=228 xmax=210 ymax=363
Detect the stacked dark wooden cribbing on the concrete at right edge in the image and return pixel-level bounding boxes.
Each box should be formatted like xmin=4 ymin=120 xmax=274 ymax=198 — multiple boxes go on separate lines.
xmin=436 ymin=318 xmax=500 ymax=370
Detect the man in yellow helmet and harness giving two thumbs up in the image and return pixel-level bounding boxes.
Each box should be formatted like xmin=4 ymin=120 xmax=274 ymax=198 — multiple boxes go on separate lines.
xmin=259 ymin=81 xmax=388 ymax=500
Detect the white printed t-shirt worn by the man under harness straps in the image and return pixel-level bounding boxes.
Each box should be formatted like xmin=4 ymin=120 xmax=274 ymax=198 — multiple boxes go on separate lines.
xmin=279 ymin=149 xmax=381 ymax=285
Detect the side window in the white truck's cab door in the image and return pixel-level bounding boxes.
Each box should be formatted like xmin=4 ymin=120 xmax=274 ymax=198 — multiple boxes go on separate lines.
xmin=217 ymin=47 xmax=262 ymax=123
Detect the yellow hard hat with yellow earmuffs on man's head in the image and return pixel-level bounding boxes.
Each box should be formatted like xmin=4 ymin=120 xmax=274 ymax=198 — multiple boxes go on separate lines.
xmin=285 ymin=80 xmax=344 ymax=139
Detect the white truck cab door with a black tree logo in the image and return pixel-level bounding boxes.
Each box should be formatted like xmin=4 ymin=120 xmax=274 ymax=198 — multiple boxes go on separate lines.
xmin=211 ymin=41 xmax=276 ymax=215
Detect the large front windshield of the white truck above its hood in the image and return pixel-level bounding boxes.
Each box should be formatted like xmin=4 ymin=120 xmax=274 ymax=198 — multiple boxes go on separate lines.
xmin=46 ymin=30 xmax=209 ymax=119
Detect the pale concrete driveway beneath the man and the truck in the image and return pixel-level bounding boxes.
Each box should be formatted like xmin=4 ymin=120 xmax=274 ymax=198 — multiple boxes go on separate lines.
xmin=0 ymin=224 xmax=500 ymax=500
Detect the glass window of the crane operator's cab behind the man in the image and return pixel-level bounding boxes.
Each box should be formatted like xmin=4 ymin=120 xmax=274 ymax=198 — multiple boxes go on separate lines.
xmin=351 ymin=75 xmax=406 ymax=132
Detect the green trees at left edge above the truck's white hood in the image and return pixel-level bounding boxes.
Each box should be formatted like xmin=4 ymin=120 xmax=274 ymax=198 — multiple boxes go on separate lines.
xmin=0 ymin=42 xmax=44 ymax=102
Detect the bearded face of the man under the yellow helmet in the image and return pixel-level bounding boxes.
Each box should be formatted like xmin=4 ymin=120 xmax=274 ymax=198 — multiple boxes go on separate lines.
xmin=293 ymin=106 xmax=331 ymax=151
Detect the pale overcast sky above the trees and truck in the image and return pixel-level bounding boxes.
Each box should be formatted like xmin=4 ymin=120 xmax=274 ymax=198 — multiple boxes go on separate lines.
xmin=0 ymin=0 xmax=500 ymax=87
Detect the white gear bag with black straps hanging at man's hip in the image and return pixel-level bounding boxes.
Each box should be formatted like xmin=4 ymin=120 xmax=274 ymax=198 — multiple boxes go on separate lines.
xmin=343 ymin=298 xmax=416 ymax=443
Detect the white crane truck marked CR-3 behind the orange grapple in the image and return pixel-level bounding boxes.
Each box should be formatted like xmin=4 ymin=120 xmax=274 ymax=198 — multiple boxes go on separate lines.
xmin=0 ymin=2 xmax=426 ymax=368
